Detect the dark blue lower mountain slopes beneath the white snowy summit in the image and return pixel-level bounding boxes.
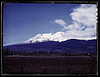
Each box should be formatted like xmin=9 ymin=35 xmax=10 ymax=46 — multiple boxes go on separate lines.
xmin=3 ymin=39 xmax=97 ymax=53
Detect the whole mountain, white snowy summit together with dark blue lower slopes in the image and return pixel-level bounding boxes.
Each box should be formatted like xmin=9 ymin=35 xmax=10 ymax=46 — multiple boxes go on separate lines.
xmin=3 ymin=32 xmax=97 ymax=53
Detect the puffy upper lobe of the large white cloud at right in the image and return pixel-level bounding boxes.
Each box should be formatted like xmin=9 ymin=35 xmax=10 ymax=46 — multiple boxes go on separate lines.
xmin=70 ymin=4 xmax=96 ymax=26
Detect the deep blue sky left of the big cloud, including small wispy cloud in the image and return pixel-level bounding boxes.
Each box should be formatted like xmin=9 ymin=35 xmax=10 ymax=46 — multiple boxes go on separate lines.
xmin=3 ymin=3 xmax=95 ymax=45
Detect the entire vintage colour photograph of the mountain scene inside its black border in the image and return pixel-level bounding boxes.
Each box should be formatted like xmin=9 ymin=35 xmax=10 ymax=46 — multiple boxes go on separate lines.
xmin=2 ymin=2 xmax=98 ymax=75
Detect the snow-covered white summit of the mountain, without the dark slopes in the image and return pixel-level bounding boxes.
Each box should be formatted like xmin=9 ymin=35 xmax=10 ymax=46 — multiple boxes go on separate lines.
xmin=25 ymin=32 xmax=67 ymax=44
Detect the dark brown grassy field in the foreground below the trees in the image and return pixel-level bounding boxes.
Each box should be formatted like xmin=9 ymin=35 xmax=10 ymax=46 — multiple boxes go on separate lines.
xmin=2 ymin=56 xmax=97 ymax=74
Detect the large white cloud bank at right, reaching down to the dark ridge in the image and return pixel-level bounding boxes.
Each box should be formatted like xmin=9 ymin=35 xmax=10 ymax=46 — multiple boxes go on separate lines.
xmin=62 ymin=4 xmax=96 ymax=40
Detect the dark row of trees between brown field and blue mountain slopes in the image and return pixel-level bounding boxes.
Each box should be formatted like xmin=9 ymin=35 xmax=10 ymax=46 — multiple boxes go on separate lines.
xmin=3 ymin=48 xmax=97 ymax=56
